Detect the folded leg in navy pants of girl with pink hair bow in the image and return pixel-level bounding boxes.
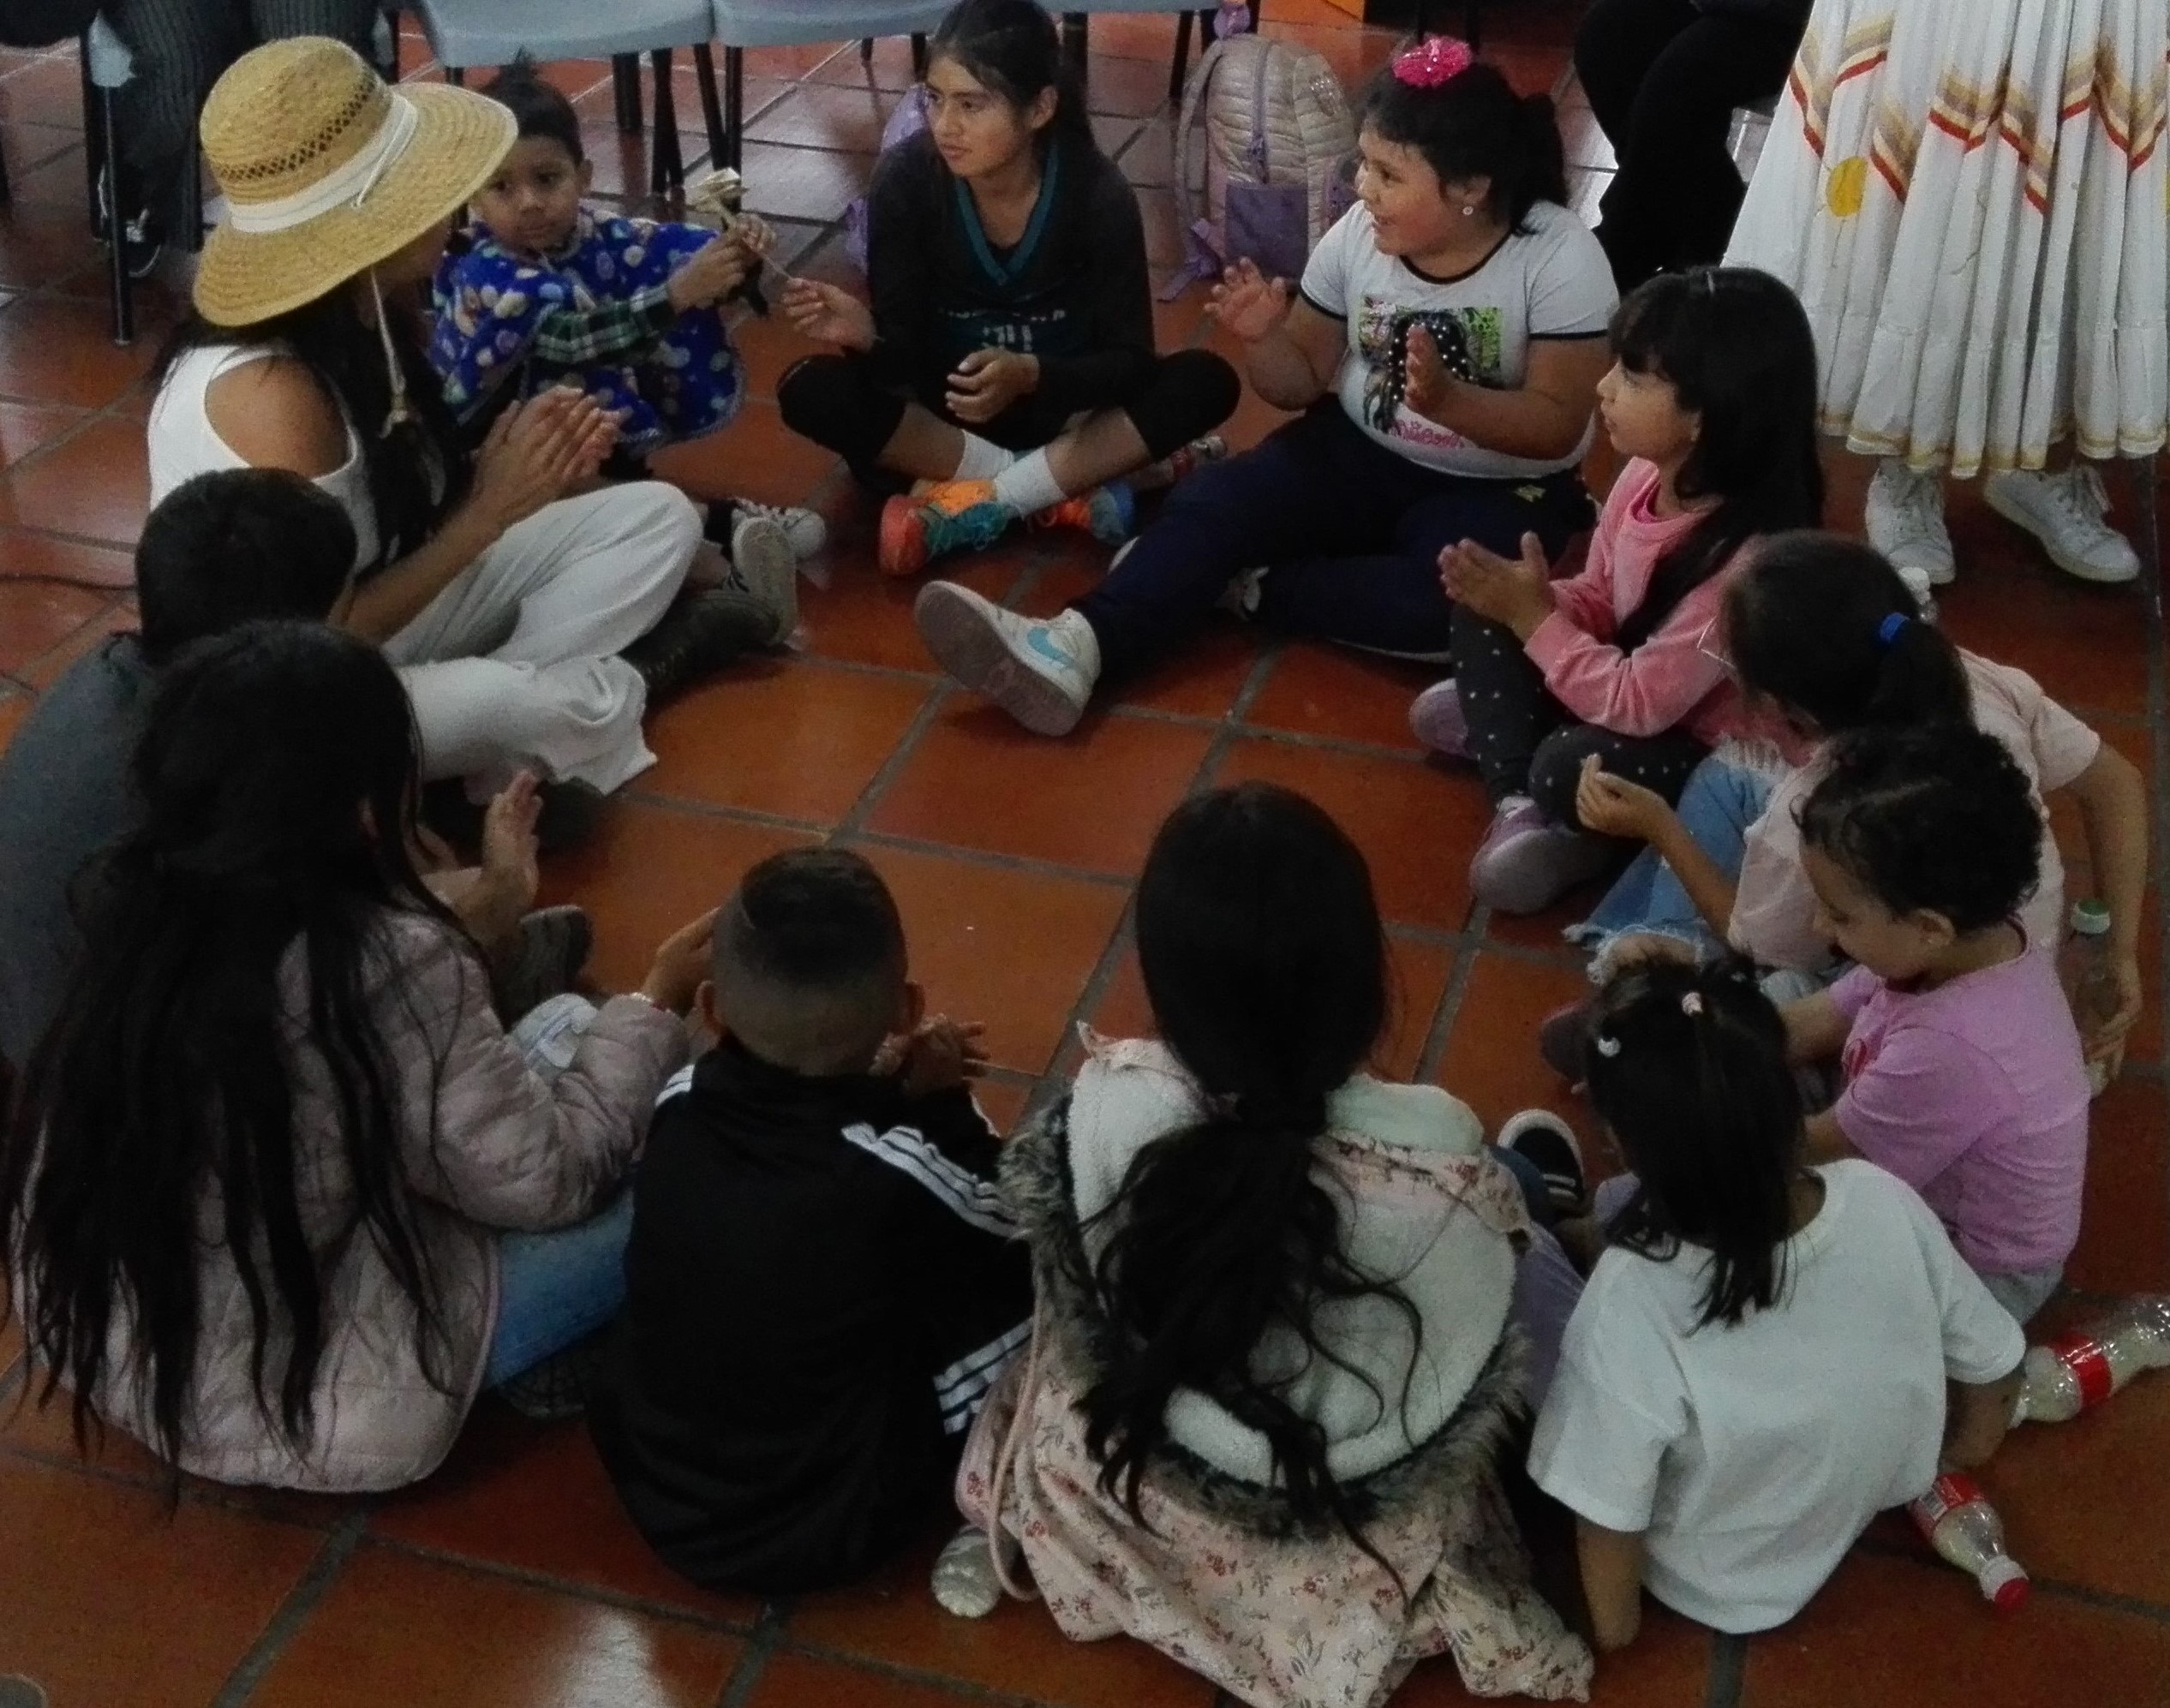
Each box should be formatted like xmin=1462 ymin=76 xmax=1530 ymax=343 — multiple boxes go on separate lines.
xmin=1257 ymin=471 xmax=1591 ymax=660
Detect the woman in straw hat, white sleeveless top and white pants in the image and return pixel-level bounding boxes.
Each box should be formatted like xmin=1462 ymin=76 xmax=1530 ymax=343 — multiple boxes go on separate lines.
xmin=150 ymin=37 xmax=797 ymax=842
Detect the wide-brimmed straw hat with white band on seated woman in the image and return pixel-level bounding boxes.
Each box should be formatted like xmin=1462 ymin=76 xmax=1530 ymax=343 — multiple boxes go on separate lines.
xmin=195 ymin=35 xmax=518 ymax=325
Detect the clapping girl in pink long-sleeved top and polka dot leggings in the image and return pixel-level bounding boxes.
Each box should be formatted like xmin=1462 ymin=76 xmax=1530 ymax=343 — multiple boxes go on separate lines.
xmin=1410 ymin=267 xmax=1823 ymax=914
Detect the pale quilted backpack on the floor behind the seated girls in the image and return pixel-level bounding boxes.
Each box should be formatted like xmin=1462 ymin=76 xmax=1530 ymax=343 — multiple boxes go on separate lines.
xmin=1163 ymin=22 xmax=1356 ymax=296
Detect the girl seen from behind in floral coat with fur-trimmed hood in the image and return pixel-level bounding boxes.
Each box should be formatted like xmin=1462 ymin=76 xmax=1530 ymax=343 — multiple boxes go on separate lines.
xmin=936 ymin=784 xmax=1591 ymax=1708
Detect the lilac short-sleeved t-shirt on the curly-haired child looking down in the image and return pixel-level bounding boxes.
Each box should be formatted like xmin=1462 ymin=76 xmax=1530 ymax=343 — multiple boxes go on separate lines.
xmin=1832 ymin=948 xmax=2088 ymax=1274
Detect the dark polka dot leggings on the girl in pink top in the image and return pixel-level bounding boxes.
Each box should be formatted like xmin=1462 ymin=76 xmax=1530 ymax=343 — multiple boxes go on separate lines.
xmin=1452 ymin=606 xmax=1710 ymax=825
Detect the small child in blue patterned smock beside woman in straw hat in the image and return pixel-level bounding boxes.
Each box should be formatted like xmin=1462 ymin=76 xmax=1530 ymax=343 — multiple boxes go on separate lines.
xmin=430 ymin=58 xmax=825 ymax=560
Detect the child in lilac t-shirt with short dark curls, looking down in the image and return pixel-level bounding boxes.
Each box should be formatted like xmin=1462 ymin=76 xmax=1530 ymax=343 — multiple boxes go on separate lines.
xmin=1786 ymin=723 xmax=2088 ymax=1324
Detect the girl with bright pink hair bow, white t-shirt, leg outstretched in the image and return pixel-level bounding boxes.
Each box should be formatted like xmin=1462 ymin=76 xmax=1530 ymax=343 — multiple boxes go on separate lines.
xmin=918 ymin=37 xmax=1617 ymax=736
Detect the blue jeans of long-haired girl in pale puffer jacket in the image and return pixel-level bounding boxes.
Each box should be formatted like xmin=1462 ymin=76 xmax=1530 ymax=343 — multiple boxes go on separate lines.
xmin=481 ymin=992 xmax=634 ymax=1387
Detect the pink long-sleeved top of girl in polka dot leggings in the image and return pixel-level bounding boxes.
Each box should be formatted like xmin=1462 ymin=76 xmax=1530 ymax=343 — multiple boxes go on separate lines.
xmin=1523 ymin=458 xmax=1743 ymax=747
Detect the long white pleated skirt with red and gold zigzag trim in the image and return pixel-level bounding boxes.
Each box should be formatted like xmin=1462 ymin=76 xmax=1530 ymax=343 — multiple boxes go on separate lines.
xmin=1725 ymin=0 xmax=2170 ymax=477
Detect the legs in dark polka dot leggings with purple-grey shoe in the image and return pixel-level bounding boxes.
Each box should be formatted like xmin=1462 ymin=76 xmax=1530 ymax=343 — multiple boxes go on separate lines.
xmin=1452 ymin=607 xmax=1706 ymax=914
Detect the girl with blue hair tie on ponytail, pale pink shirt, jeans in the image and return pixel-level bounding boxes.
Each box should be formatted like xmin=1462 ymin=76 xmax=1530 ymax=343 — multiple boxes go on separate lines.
xmin=1547 ymin=532 xmax=2149 ymax=1068
